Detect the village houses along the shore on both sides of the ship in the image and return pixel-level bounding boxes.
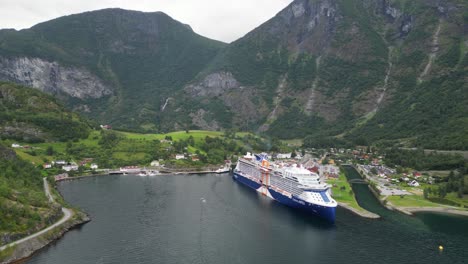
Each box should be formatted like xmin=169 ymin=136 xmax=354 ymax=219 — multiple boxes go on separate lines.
xmin=11 ymin=138 xmax=462 ymax=208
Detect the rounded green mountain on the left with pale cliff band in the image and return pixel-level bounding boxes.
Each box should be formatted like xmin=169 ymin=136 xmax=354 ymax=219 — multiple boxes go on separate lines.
xmin=0 ymin=9 xmax=224 ymax=130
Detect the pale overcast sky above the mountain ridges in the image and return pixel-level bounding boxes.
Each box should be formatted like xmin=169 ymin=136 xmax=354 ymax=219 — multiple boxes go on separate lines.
xmin=0 ymin=0 xmax=292 ymax=42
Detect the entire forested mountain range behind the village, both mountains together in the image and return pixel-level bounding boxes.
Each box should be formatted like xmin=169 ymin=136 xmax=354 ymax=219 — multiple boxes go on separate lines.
xmin=0 ymin=0 xmax=468 ymax=149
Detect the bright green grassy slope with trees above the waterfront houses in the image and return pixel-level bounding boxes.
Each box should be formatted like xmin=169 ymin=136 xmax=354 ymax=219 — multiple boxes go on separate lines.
xmin=11 ymin=130 xmax=268 ymax=168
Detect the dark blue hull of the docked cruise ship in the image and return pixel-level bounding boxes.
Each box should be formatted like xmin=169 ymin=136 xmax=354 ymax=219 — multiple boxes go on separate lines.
xmin=233 ymin=173 xmax=336 ymax=223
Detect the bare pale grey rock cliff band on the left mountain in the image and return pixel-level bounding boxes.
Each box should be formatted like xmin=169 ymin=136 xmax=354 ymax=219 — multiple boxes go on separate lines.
xmin=0 ymin=57 xmax=114 ymax=99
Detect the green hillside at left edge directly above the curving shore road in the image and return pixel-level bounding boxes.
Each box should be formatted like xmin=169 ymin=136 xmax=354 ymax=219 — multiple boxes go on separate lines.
xmin=0 ymin=145 xmax=62 ymax=245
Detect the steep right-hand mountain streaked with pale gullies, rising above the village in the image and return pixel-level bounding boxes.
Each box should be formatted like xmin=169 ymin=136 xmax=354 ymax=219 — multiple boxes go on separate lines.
xmin=174 ymin=0 xmax=468 ymax=148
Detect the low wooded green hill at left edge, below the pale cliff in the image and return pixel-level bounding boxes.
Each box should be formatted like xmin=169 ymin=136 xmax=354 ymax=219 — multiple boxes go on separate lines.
xmin=0 ymin=82 xmax=92 ymax=143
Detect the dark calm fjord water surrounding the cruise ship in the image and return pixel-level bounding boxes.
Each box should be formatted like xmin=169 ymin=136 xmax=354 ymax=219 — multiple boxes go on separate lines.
xmin=26 ymin=171 xmax=468 ymax=264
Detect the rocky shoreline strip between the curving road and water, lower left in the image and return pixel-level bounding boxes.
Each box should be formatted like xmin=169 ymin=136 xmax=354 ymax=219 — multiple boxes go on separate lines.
xmin=0 ymin=210 xmax=91 ymax=264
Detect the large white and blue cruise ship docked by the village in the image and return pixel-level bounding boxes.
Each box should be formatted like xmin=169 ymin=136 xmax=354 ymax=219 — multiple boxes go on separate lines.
xmin=233 ymin=153 xmax=337 ymax=223
